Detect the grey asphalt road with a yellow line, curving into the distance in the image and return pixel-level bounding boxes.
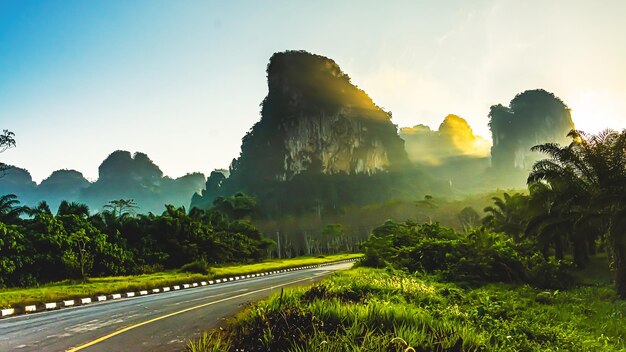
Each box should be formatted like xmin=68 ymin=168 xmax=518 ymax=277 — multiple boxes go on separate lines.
xmin=0 ymin=263 xmax=352 ymax=352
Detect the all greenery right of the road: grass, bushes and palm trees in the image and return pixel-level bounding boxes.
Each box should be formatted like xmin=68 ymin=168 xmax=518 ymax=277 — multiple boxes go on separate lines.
xmin=188 ymin=130 xmax=626 ymax=352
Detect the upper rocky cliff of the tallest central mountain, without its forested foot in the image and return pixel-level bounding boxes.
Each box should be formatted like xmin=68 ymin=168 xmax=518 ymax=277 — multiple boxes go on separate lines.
xmin=233 ymin=51 xmax=407 ymax=184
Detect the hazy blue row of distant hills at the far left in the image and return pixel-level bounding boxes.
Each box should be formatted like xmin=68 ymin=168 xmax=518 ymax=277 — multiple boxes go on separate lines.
xmin=0 ymin=150 xmax=206 ymax=213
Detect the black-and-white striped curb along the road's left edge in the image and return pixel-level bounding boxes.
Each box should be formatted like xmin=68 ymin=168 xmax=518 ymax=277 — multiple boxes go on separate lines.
xmin=0 ymin=258 xmax=361 ymax=319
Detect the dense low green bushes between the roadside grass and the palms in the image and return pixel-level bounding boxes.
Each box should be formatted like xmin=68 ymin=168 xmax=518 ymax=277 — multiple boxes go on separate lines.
xmin=363 ymin=221 xmax=571 ymax=287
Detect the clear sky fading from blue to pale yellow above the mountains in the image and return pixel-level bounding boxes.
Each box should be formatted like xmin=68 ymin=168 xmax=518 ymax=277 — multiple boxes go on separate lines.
xmin=0 ymin=0 xmax=626 ymax=182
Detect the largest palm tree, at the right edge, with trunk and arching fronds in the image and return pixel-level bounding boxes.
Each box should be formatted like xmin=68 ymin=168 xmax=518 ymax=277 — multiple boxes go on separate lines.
xmin=528 ymin=130 xmax=626 ymax=298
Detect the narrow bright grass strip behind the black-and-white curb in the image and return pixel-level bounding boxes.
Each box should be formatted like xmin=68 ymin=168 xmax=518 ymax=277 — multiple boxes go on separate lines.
xmin=0 ymin=254 xmax=362 ymax=308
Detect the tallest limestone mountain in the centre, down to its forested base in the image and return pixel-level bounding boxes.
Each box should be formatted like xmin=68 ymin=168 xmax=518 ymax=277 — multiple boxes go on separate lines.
xmin=192 ymin=51 xmax=409 ymax=211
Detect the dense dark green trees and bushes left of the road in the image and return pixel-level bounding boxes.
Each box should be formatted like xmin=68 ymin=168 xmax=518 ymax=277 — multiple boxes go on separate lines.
xmin=0 ymin=194 xmax=274 ymax=286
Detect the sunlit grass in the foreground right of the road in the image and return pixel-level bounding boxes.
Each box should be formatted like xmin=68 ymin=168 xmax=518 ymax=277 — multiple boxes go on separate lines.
xmin=188 ymin=268 xmax=626 ymax=352
